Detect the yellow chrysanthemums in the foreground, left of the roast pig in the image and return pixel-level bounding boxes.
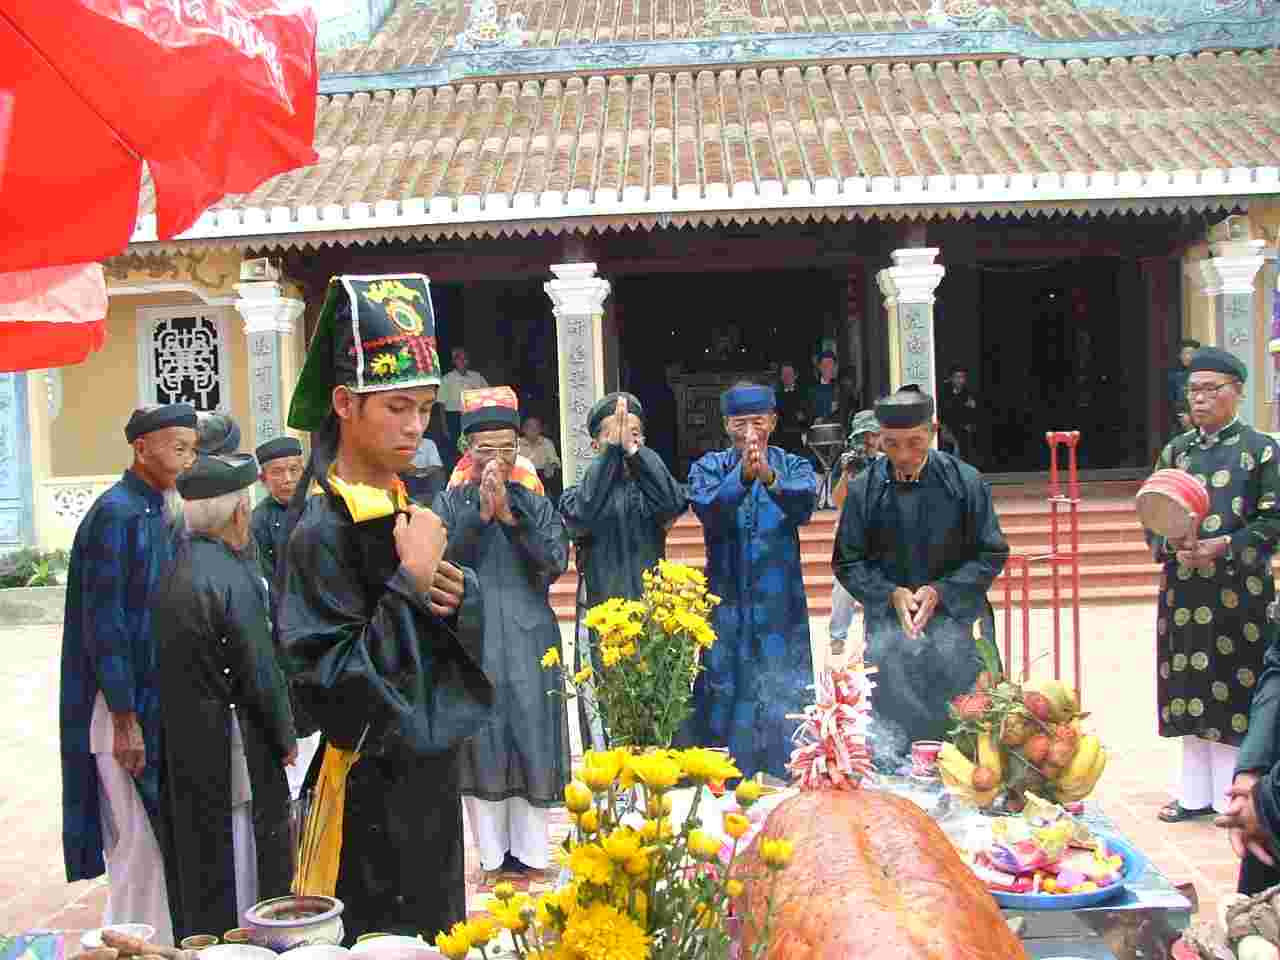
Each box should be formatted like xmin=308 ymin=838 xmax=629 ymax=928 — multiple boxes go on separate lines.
xmin=435 ymin=748 xmax=792 ymax=960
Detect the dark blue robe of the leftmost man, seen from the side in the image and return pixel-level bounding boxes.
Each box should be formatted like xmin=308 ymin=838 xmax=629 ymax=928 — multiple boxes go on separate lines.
xmin=59 ymin=471 xmax=174 ymax=882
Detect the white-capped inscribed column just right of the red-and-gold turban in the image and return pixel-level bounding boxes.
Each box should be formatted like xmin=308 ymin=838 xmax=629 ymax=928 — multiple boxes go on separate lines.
xmin=544 ymin=264 xmax=611 ymax=486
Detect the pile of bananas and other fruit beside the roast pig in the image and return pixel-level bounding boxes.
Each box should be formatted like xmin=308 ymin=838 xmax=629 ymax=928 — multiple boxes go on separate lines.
xmin=938 ymin=641 xmax=1107 ymax=813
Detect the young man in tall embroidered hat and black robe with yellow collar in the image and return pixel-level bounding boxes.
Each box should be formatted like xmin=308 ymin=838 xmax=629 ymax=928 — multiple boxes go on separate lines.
xmin=278 ymin=275 xmax=494 ymax=941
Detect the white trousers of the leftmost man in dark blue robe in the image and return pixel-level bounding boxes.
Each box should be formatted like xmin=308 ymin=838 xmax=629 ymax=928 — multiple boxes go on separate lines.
xmin=93 ymin=753 xmax=173 ymax=947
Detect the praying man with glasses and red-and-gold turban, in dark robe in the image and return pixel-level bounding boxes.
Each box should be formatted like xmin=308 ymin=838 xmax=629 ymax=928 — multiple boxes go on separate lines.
xmin=434 ymin=387 xmax=570 ymax=881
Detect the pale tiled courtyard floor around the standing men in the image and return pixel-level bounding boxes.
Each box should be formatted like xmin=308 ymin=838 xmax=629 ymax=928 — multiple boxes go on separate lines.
xmin=0 ymin=604 xmax=1235 ymax=932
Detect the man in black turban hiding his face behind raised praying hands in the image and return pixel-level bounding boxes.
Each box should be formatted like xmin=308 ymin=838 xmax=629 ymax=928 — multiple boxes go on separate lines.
xmin=559 ymin=393 xmax=687 ymax=748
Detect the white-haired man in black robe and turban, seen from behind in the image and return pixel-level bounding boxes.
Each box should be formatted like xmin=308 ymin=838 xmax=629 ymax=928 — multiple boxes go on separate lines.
xmin=151 ymin=454 xmax=298 ymax=940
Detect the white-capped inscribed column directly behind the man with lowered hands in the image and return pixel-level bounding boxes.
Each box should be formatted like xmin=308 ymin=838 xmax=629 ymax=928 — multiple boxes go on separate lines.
xmin=877 ymin=247 xmax=946 ymax=397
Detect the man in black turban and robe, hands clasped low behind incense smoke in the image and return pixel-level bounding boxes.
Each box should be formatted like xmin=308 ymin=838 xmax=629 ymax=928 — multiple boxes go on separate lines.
xmin=832 ymin=390 xmax=1009 ymax=767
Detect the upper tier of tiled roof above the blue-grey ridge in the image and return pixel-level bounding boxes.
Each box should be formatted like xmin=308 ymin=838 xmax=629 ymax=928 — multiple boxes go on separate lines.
xmin=320 ymin=0 xmax=1155 ymax=73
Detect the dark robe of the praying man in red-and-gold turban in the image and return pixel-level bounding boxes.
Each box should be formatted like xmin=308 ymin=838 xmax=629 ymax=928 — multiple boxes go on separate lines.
xmin=434 ymin=483 xmax=570 ymax=808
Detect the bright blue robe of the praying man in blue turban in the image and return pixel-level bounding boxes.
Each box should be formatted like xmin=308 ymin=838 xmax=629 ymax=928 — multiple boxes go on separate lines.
xmin=689 ymin=447 xmax=818 ymax=777
